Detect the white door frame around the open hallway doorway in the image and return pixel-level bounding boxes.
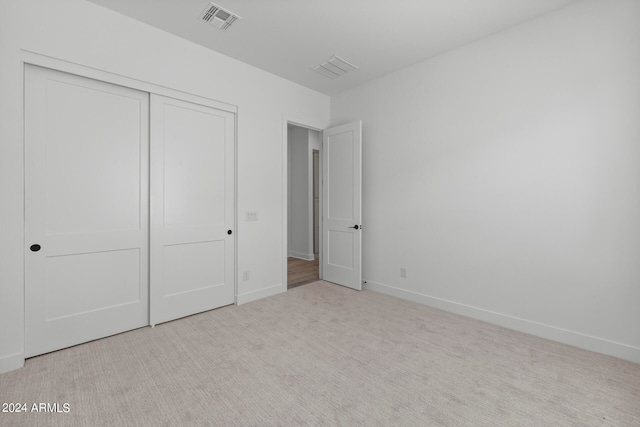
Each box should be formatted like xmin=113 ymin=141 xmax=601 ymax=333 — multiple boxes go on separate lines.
xmin=281 ymin=115 xmax=328 ymax=292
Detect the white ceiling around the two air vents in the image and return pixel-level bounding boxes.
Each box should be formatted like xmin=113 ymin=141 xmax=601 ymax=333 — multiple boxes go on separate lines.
xmin=88 ymin=0 xmax=576 ymax=95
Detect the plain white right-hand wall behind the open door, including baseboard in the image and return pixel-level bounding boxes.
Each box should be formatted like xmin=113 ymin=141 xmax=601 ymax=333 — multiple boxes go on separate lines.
xmin=331 ymin=0 xmax=640 ymax=362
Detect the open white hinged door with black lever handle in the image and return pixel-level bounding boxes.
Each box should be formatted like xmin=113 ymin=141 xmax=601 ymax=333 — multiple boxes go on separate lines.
xmin=322 ymin=121 xmax=362 ymax=290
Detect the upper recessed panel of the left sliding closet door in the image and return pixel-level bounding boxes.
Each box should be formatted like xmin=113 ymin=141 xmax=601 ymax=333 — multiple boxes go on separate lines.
xmin=43 ymin=78 xmax=146 ymax=234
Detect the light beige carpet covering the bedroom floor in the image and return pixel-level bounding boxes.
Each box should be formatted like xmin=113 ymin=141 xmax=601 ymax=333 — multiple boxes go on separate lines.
xmin=0 ymin=282 xmax=640 ymax=426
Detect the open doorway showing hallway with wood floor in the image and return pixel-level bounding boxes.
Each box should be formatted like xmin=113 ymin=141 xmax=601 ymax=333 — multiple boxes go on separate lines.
xmin=287 ymin=124 xmax=322 ymax=289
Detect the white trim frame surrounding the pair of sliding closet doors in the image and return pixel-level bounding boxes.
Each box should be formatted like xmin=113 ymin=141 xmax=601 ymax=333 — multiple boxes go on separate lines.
xmin=19 ymin=49 xmax=240 ymax=371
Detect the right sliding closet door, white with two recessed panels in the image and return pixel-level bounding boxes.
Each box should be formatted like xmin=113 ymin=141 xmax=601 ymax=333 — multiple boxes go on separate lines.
xmin=150 ymin=95 xmax=235 ymax=325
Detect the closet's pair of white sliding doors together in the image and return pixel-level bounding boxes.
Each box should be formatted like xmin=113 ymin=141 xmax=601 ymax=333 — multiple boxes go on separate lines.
xmin=24 ymin=65 xmax=235 ymax=357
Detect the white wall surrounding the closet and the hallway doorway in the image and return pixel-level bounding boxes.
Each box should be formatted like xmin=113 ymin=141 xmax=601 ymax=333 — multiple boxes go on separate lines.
xmin=0 ymin=0 xmax=329 ymax=372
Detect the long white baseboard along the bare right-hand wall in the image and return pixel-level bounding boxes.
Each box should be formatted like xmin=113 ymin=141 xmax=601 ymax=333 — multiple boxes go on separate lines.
xmin=363 ymin=280 xmax=640 ymax=363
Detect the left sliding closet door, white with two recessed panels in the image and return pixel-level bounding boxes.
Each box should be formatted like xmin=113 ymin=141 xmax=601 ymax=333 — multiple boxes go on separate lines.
xmin=25 ymin=66 xmax=149 ymax=357
